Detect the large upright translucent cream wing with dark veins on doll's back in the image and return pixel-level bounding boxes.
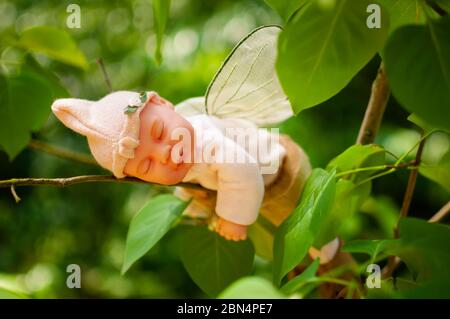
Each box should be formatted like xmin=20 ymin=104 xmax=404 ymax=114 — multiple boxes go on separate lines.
xmin=206 ymin=26 xmax=293 ymax=127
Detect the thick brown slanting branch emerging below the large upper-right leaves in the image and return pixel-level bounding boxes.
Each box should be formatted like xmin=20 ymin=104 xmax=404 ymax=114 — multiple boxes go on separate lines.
xmin=356 ymin=62 xmax=390 ymax=145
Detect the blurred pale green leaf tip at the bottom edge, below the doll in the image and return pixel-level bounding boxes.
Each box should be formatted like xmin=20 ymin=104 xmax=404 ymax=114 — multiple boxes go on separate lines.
xmin=218 ymin=277 xmax=286 ymax=299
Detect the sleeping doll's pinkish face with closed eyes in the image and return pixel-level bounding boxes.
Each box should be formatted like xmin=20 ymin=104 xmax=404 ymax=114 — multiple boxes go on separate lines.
xmin=124 ymin=104 xmax=194 ymax=185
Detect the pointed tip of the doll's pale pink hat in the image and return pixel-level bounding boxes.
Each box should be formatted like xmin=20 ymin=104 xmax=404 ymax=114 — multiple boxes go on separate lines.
xmin=52 ymin=99 xmax=94 ymax=136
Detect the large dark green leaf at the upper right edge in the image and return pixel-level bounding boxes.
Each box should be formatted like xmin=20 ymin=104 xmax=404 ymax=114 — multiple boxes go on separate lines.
xmin=384 ymin=17 xmax=450 ymax=130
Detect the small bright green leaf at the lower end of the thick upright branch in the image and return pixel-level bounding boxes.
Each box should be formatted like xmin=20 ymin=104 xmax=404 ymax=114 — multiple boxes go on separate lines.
xmin=327 ymin=144 xmax=385 ymax=183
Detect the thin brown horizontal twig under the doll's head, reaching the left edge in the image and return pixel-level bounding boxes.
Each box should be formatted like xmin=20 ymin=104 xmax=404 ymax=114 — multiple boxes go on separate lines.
xmin=0 ymin=175 xmax=201 ymax=188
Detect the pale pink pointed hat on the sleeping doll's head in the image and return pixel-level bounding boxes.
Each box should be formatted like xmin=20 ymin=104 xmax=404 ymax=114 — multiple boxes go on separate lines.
xmin=52 ymin=91 xmax=170 ymax=178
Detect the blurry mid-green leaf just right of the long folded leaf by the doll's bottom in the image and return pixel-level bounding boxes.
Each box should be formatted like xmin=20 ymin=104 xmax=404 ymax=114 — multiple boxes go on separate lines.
xmin=314 ymin=179 xmax=371 ymax=247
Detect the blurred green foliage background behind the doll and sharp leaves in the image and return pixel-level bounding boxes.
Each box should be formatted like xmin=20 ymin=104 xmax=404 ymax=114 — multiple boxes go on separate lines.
xmin=0 ymin=0 xmax=450 ymax=298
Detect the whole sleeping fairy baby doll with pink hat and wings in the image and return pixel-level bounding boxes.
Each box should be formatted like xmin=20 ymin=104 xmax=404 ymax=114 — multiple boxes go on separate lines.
xmin=52 ymin=26 xmax=311 ymax=241
